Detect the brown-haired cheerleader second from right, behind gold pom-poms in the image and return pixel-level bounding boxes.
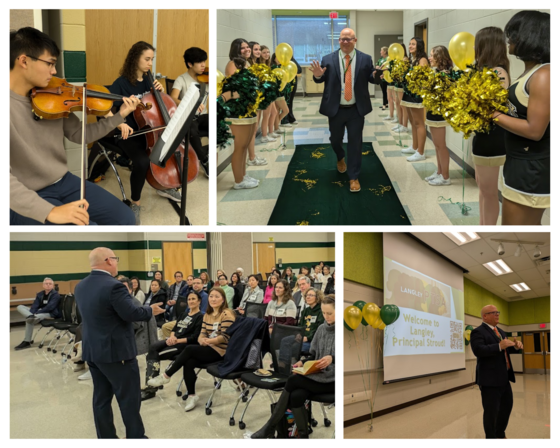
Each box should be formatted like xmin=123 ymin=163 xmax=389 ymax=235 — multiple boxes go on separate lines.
xmin=472 ymin=26 xmax=510 ymax=226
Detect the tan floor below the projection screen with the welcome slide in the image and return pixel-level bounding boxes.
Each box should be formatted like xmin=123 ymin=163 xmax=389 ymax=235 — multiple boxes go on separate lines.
xmin=344 ymin=375 xmax=550 ymax=439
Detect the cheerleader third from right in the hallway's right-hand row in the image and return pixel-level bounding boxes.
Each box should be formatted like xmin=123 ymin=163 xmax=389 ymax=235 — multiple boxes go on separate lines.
xmin=425 ymin=45 xmax=453 ymax=186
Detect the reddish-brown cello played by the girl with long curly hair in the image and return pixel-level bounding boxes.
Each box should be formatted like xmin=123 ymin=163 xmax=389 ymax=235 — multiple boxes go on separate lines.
xmin=134 ymin=71 xmax=198 ymax=190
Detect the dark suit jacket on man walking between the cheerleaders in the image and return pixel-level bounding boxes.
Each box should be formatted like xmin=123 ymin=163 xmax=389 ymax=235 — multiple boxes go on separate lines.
xmin=313 ymin=50 xmax=374 ymax=118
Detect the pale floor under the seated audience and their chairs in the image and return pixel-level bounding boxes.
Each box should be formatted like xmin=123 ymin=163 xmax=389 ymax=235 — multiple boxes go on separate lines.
xmin=8 ymin=327 xmax=335 ymax=439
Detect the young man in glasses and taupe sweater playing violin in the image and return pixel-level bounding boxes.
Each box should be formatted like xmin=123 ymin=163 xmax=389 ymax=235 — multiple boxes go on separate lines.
xmin=10 ymin=27 xmax=139 ymax=225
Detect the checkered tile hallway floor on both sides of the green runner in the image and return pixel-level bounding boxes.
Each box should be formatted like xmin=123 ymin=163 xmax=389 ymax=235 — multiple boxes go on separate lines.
xmin=217 ymin=97 xmax=550 ymax=225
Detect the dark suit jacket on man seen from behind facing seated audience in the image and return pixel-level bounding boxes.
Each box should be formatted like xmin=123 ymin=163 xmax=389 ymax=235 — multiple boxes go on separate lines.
xmin=76 ymin=271 xmax=152 ymax=363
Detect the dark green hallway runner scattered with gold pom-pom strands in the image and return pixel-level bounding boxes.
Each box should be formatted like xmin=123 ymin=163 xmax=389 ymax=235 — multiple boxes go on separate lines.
xmin=268 ymin=142 xmax=410 ymax=226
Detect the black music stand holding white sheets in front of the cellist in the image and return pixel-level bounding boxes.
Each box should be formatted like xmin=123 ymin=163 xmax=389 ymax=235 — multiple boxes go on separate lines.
xmin=150 ymin=84 xmax=206 ymax=226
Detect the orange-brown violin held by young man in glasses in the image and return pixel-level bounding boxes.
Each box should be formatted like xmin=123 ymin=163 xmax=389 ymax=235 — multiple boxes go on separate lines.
xmin=30 ymin=76 xmax=152 ymax=120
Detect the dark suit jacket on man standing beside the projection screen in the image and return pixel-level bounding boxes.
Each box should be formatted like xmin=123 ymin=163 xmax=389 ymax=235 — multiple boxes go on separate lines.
xmin=471 ymin=323 xmax=515 ymax=387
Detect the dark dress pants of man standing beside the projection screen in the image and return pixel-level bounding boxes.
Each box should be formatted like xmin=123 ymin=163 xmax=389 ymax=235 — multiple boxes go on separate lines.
xmin=480 ymin=382 xmax=513 ymax=439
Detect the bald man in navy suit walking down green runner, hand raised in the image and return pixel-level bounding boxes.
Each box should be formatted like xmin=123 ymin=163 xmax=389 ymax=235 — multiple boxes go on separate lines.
xmin=309 ymin=28 xmax=374 ymax=193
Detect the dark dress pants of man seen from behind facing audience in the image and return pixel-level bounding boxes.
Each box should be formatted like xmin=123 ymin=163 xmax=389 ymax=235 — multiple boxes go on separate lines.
xmin=88 ymin=358 xmax=147 ymax=439
